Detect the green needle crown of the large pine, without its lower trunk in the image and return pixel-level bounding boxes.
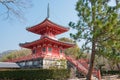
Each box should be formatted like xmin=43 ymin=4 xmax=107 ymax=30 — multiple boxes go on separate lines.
xmin=69 ymin=0 xmax=120 ymax=50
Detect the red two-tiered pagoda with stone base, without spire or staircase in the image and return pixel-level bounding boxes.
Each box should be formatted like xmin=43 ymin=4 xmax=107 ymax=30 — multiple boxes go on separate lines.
xmin=14 ymin=18 xmax=74 ymax=68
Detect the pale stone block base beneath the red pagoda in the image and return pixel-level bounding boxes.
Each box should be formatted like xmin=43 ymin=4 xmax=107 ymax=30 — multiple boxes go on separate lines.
xmin=16 ymin=56 xmax=67 ymax=69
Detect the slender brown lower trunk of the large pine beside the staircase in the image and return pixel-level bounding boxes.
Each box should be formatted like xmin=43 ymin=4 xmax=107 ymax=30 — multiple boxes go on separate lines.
xmin=86 ymin=41 xmax=95 ymax=80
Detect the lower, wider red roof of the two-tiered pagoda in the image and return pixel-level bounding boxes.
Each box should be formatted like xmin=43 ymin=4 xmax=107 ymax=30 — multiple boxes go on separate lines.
xmin=20 ymin=36 xmax=75 ymax=49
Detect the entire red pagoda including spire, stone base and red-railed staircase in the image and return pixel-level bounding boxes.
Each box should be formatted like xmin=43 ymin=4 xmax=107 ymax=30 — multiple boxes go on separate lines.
xmin=5 ymin=4 xmax=101 ymax=80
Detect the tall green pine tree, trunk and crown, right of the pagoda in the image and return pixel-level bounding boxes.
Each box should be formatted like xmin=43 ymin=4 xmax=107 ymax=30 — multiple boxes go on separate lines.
xmin=69 ymin=0 xmax=120 ymax=80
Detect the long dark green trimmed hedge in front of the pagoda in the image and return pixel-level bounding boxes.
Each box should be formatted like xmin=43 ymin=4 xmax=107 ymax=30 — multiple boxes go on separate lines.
xmin=0 ymin=69 xmax=70 ymax=80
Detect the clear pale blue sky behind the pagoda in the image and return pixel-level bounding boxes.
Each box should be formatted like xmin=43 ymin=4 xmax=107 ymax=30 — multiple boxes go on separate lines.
xmin=0 ymin=0 xmax=116 ymax=53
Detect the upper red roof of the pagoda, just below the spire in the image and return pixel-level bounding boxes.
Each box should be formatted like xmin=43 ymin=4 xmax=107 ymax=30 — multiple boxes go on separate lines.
xmin=27 ymin=18 xmax=69 ymax=35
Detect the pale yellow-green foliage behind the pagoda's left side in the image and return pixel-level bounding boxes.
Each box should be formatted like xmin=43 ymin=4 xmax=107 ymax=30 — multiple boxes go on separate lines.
xmin=0 ymin=49 xmax=31 ymax=61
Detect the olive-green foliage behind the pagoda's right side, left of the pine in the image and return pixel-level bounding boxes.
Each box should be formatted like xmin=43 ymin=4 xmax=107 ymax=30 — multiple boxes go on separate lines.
xmin=59 ymin=37 xmax=86 ymax=59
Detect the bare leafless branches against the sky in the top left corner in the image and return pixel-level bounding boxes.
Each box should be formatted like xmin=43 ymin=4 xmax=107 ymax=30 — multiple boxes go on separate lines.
xmin=0 ymin=0 xmax=31 ymax=19
